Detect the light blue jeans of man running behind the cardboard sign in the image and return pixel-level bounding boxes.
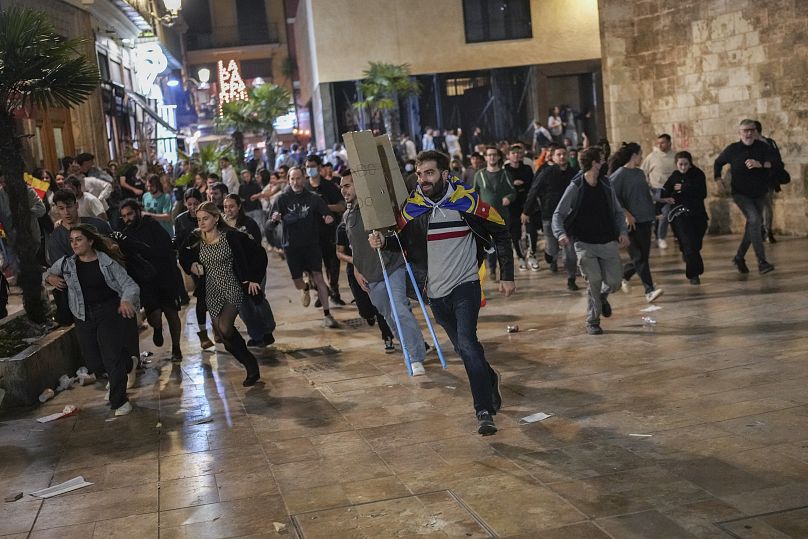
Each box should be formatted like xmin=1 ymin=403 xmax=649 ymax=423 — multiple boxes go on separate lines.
xmin=368 ymin=266 xmax=426 ymax=363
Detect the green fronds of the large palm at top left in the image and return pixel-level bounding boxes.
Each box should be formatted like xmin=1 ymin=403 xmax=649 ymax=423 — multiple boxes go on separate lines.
xmin=0 ymin=7 xmax=101 ymax=114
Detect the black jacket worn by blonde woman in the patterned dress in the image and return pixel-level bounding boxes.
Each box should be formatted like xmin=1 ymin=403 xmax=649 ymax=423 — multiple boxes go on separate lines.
xmin=179 ymin=229 xmax=267 ymax=303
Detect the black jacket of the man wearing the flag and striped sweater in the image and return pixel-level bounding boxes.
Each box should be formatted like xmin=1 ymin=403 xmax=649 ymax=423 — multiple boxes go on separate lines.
xmin=385 ymin=207 xmax=513 ymax=300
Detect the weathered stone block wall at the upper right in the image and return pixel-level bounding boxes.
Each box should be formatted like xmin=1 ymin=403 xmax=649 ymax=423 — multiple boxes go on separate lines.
xmin=598 ymin=0 xmax=808 ymax=235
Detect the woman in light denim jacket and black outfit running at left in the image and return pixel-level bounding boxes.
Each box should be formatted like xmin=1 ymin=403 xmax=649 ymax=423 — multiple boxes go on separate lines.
xmin=43 ymin=224 xmax=140 ymax=416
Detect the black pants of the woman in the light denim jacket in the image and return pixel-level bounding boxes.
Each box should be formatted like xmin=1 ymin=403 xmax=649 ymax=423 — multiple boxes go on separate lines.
xmin=76 ymin=298 xmax=136 ymax=410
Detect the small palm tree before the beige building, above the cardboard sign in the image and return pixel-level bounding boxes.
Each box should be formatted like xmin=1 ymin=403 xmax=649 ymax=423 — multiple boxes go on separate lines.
xmin=354 ymin=62 xmax=421 ymax=140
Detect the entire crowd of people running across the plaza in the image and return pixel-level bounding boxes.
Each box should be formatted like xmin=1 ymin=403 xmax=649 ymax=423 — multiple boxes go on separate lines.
xmin=0 ymin=115 xmax=789 ymax=435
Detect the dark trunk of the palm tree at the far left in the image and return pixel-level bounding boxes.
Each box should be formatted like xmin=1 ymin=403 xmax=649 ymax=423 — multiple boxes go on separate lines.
xmin=0 ymin=114 xmax=47 ymax=324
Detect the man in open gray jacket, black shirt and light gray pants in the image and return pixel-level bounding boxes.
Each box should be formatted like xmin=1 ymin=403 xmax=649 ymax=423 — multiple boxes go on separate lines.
xmin=553 ymin=146 xmax=629 ymax=335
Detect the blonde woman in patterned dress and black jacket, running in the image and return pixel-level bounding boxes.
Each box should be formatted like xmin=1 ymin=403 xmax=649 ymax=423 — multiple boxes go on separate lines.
xmin=180 ymin=202 xmax=267 ymax=387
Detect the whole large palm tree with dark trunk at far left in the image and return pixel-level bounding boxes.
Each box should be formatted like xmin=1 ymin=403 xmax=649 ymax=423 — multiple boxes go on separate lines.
xmin=0 ymin=7 xmax=101 ymax=323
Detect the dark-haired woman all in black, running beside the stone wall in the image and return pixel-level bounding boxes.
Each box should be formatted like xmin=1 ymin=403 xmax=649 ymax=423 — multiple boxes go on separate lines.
xmin=663 ymin=152 xmax=707 ymax=285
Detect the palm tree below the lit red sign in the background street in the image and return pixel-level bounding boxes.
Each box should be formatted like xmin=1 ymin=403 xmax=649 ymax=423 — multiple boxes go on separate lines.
xmin=217 ymin=84 xmax=292 ymax=164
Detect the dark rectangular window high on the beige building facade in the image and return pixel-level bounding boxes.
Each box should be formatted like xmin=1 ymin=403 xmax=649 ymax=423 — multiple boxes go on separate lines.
xmin=463 ymin=0 xmax=533 ymax=43
